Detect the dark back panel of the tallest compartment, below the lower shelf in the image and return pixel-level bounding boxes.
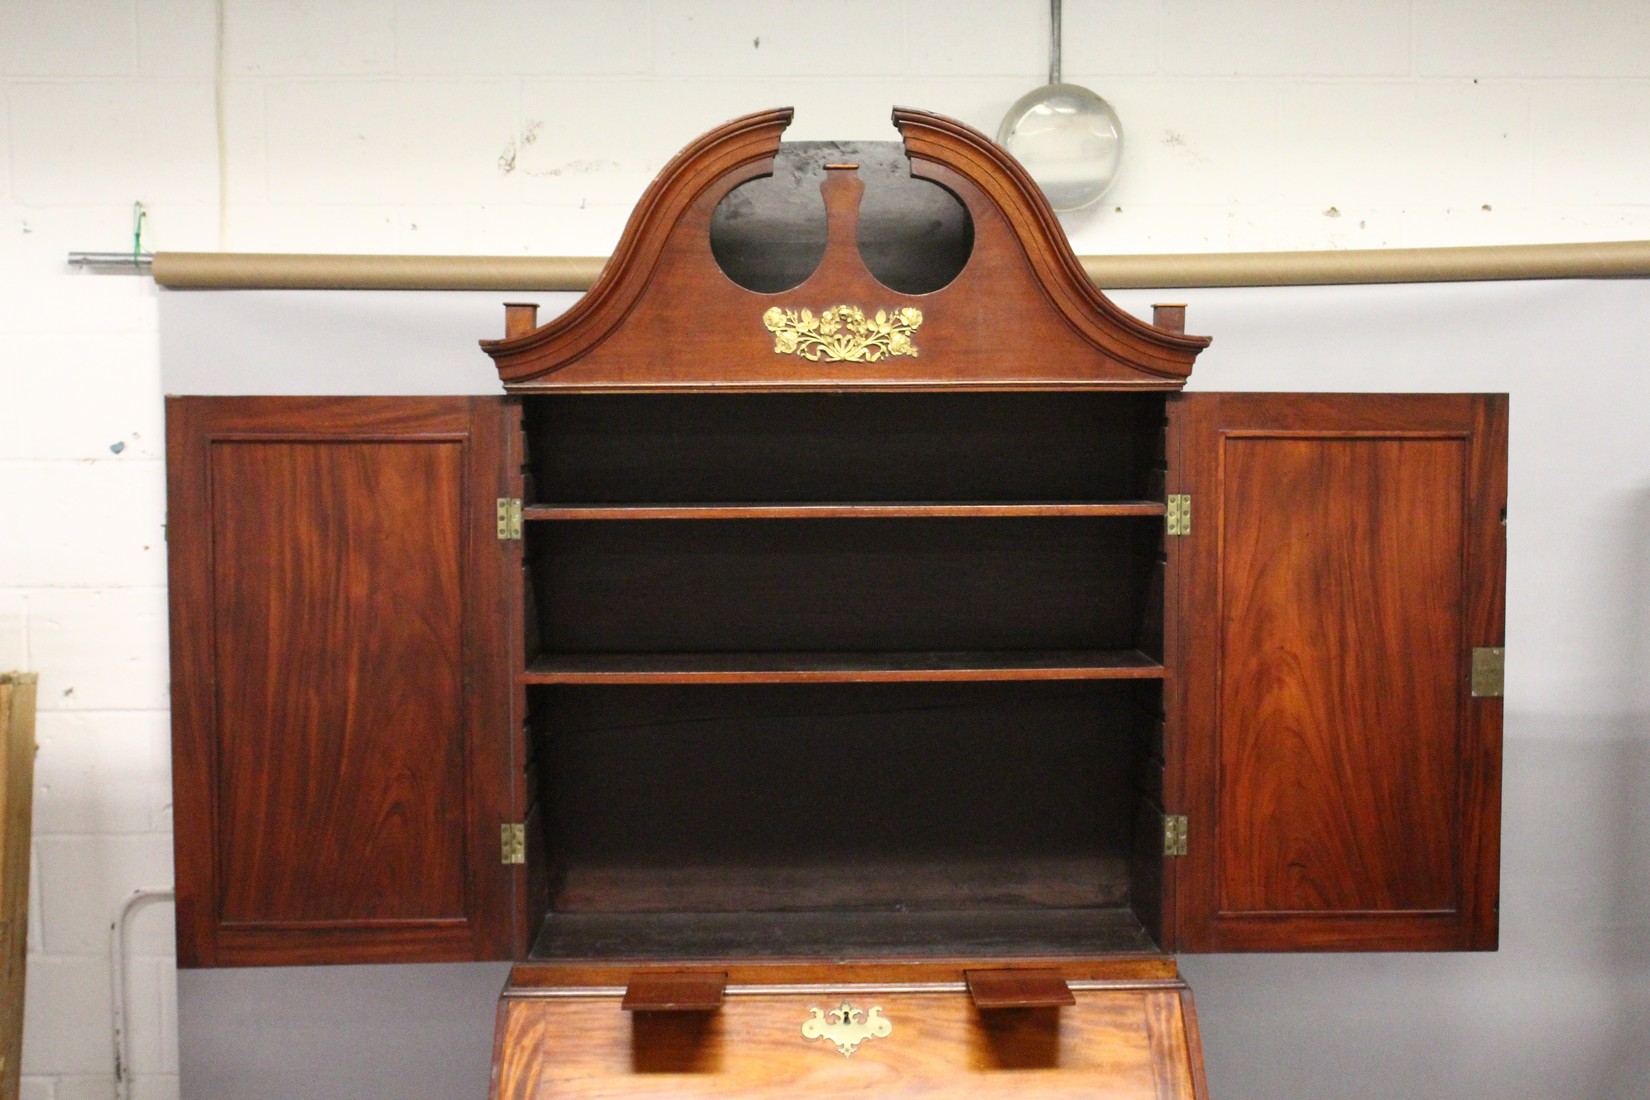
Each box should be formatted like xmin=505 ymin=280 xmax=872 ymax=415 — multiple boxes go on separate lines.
xmin=535 ymin=683 xmax=1158 ymax=912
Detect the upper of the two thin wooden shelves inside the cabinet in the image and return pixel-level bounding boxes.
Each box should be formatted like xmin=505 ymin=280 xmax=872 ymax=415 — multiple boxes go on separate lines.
xmin=521 ymin=500 xmax=1163 ymax=521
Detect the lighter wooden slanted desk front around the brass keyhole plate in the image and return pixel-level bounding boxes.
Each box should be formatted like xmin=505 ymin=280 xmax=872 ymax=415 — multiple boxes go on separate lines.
xmin=490 ymin=981 xmax=1208 ymax=1100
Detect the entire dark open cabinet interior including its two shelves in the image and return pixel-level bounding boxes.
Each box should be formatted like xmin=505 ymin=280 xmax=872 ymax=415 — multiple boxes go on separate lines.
xmin=521 ymin=393 xmax=1165 ymax=958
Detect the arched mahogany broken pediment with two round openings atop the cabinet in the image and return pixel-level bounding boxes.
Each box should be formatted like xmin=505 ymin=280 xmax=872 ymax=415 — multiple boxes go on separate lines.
xmin=483 ymin=110 xmax=1208 ymax=391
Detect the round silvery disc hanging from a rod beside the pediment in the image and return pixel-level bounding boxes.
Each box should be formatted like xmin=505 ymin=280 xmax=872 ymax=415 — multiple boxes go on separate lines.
xmin=997 ymin=84 xmax=1124 ymax=211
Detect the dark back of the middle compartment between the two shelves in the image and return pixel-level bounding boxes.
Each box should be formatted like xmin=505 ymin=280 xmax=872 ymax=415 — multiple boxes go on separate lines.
xmin=528 ymin=518 xmax=1162 ymax=653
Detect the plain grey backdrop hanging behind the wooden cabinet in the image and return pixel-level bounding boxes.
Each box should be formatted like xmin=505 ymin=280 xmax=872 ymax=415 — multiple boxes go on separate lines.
xmin=162 ymin=280 xmax=1650 ymax=1100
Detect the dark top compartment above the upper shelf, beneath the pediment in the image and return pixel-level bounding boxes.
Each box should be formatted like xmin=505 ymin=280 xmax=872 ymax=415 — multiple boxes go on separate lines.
xmin=526 ymin=393 xmax=1163 ymax=503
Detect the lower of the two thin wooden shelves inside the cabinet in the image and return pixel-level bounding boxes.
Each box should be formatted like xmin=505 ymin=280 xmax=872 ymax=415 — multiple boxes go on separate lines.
xmin=521 ymin=650 xmax=1168 ymax=684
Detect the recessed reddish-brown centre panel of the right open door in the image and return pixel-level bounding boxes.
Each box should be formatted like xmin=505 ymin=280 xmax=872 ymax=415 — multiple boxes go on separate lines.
xmin=1214 ymin=435 xmax=1469 ymax=914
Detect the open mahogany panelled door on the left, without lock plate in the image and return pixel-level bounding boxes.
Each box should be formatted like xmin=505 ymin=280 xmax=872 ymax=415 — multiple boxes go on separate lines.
xmin=167 ymin=397 xmax=520 ymax=966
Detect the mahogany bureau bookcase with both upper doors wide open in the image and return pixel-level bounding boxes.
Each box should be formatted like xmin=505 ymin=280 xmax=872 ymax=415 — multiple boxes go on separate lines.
xmin=168 ymin=109 xmax=1506 ymax=1098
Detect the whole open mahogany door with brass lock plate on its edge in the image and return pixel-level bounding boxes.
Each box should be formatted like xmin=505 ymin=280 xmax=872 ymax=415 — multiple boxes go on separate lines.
xmin=1170 ymin=394 xmax=1506 ymax=952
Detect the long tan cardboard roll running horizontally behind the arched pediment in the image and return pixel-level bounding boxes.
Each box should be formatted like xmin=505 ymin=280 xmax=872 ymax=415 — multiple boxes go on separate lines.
xmin=153 ymin=241 xmax=1650 ymax=290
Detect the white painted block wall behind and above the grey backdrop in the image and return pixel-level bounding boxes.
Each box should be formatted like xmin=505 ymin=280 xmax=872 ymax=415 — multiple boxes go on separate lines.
xmin=0 ymin=0 xmax=1650 ymax=1100
